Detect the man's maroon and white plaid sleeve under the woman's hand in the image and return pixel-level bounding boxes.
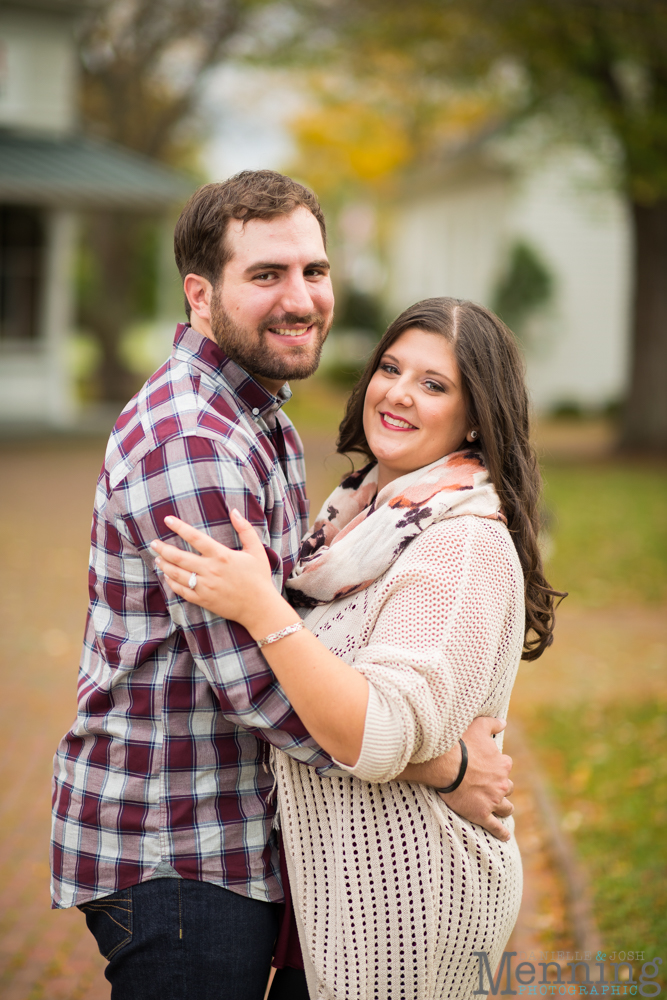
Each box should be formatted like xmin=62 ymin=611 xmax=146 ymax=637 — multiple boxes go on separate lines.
xmin=91 ymin=435 xmax=331 ymax=771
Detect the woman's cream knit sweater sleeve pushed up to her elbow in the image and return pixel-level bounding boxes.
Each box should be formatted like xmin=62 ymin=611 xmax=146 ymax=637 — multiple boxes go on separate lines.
xmin=334 ymin=517 xmax=524 ymax=782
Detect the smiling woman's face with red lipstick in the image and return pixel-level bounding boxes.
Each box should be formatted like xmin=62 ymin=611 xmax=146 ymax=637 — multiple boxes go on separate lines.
xmin=364 ymin=327 xmax=472 ymax=489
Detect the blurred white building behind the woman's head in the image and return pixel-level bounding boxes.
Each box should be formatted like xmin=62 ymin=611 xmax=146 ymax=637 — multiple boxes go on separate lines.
xmin=387 ymin=138 xmax=631 ymax=411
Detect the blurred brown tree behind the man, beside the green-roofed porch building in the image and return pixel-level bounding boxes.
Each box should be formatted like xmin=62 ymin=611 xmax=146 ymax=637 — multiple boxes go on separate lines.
xmin=75 ymin=0 xmax=263 ymax=400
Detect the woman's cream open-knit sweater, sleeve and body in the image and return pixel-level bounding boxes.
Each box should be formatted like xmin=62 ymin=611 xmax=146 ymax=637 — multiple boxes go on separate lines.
xmin=274 ymin=516 xmax=524 ymax=1000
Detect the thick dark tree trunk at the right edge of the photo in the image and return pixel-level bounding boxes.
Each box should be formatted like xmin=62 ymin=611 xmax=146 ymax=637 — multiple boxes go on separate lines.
xmin=621 ymin=201 xmax=667 ymax=450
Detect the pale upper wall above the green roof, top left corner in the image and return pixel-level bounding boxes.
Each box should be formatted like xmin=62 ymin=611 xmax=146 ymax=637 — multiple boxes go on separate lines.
xmin=0 ymin=9 xmax=77 ymax=135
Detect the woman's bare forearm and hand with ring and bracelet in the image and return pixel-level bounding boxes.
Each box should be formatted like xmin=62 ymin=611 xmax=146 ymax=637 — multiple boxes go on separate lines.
xmin=151 ymin=510 xmax=368 ymax=767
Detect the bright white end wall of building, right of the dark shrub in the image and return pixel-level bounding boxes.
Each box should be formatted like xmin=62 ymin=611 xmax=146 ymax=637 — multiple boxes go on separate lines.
xmin=508 ymin=147 xmax=632 ymax=407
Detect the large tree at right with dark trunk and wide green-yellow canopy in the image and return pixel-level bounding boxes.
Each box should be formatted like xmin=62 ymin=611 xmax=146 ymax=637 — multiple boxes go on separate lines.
xmin=304 ymin=0 xmax=667 ymax=449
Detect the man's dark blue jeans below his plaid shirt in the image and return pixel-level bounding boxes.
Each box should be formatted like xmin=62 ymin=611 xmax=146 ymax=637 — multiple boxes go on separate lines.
xmin=80 ymin=878 xmax=308 ymax=1000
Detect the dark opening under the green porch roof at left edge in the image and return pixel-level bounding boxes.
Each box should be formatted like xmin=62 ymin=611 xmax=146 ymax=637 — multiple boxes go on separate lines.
xmin=0 ymin=205 xmax=44 ymax=344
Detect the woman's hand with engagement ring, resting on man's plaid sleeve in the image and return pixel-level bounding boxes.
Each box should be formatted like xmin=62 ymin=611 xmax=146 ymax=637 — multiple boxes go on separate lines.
xmin=151 ymin=510 xmax=282 ymax=628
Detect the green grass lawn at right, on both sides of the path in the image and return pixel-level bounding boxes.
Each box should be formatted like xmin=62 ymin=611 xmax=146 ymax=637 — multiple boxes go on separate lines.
xmin=536 ymin=461 xmax=667 ymax=960
